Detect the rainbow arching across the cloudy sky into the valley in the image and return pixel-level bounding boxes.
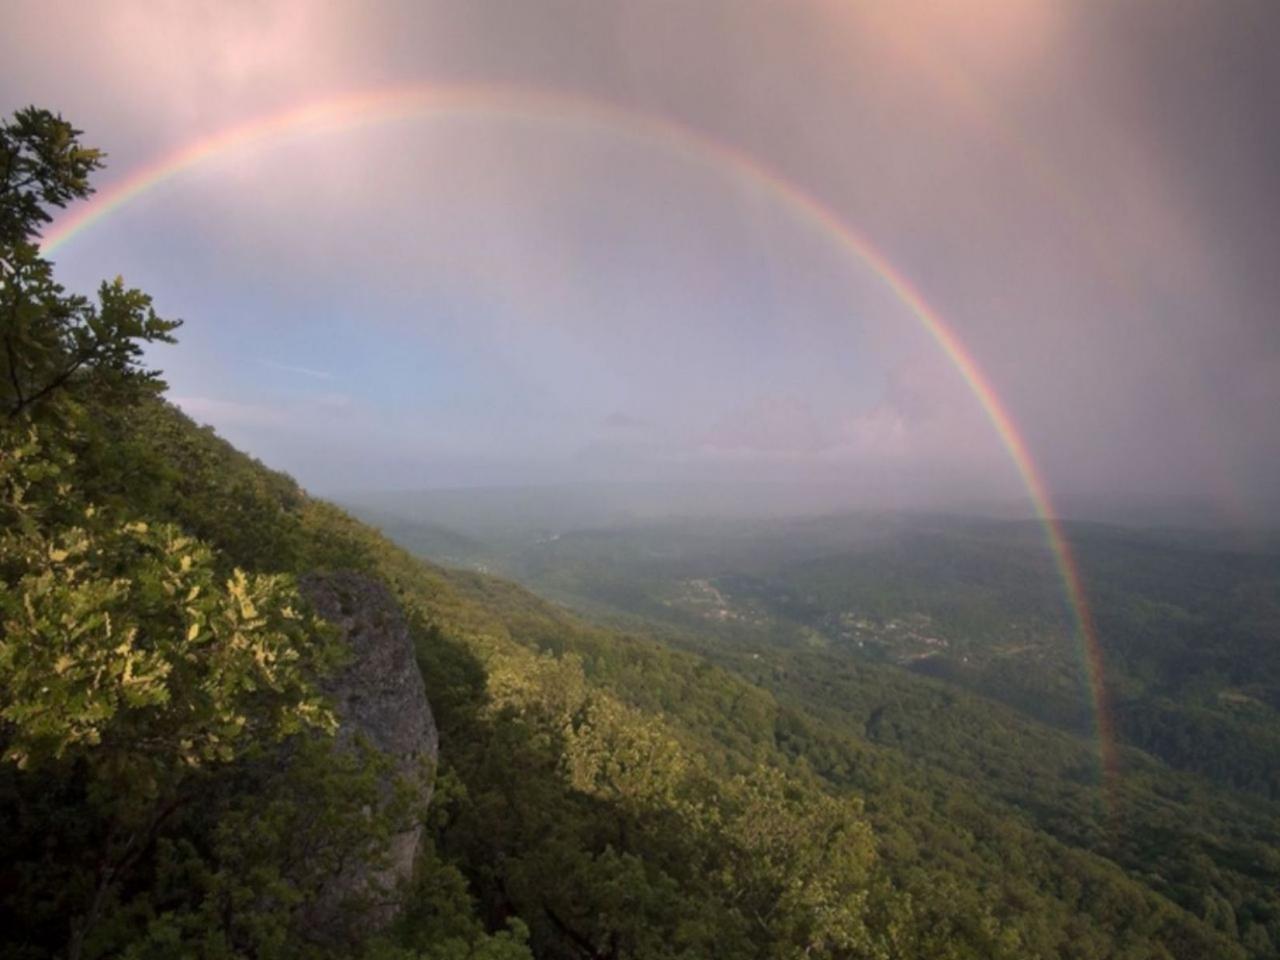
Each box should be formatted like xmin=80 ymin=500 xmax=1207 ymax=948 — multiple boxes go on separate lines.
xmin=41 ymin=86 xmax=1117 ymax=782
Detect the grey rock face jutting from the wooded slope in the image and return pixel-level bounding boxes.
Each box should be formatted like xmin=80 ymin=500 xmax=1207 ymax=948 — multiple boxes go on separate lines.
xmin=298 ymin=573 xmax=439 ymax=932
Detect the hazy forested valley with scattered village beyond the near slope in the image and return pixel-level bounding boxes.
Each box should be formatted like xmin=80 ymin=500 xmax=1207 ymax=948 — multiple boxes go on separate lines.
xmin=350 ymin=506 xmax=1277 ymax=956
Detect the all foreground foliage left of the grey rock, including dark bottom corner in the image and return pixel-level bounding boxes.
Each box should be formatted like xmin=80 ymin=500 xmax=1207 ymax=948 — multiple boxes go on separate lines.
xmin=0 ymin=110 xmax=412 ymax=960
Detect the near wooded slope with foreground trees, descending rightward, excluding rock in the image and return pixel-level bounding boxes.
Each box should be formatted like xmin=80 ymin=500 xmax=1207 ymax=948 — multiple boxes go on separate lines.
xmin=0 ymin=110 xmax=1280 ymax=960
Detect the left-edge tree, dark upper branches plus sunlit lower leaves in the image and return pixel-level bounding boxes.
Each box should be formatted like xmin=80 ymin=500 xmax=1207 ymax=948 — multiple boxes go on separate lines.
xmin=0 ymin=108 xmax=348 ymax=960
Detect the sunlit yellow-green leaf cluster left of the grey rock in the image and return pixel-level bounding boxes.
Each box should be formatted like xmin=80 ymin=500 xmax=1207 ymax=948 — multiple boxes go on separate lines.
xmin=0 ymin=427 xmax=334 ymax=773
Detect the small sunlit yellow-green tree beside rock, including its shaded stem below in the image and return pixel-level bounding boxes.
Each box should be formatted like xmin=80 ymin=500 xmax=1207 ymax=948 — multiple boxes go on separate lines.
xmin=0 ymin=428 xmax=337 ymax=959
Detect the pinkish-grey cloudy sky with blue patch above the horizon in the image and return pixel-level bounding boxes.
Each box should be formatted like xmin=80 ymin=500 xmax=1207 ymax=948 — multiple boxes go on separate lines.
xmin=0 ymin=0 xmax=1280 ymax=524
